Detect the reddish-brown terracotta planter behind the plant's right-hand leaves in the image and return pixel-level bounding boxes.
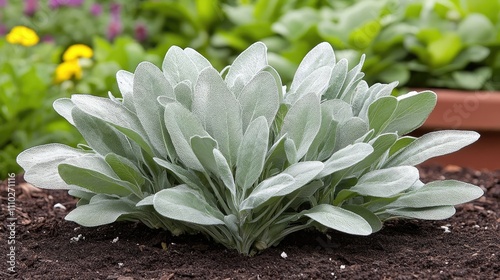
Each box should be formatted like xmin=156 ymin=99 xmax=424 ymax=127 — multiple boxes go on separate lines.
xmin=415 ymin=89 xmax=500 ymax=170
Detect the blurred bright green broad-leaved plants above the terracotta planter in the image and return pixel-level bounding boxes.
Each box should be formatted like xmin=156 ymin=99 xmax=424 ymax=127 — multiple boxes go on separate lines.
xmin=211 ymin=0 xmax=500 ymax=90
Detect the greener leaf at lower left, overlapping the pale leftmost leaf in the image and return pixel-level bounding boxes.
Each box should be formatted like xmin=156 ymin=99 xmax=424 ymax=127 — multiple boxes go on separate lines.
xmin=58 ymin=154 xmax=141 ymax=196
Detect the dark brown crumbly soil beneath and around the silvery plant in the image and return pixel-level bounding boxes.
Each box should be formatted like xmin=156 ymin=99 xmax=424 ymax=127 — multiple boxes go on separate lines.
xmin=0 ymin=166 xmax=500 ymax=280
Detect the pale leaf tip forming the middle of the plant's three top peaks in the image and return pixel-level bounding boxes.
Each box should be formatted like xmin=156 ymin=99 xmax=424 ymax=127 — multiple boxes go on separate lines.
xmin=225 ymin=42 xmax=267 ymax=92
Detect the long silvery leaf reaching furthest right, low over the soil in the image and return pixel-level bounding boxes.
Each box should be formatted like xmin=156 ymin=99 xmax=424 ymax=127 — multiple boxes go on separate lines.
xmin=388 ymin=180 xmax=484 ymax=208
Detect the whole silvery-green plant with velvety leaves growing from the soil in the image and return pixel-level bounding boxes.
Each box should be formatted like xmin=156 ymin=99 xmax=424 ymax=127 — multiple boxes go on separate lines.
xmin=17 ymin=43 xmax=483 ymax=255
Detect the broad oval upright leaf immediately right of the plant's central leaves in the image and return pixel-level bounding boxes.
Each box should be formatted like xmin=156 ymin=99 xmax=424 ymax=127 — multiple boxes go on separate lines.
xmin=281 ymin=93 xmax=321 ymax=159
